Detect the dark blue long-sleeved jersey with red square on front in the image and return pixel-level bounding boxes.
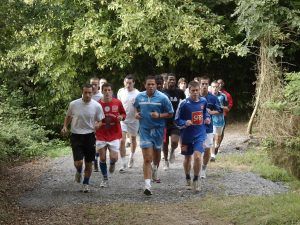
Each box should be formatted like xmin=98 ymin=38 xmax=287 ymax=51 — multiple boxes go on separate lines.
xmin=175 ymin=97 xmax=210 ymax=144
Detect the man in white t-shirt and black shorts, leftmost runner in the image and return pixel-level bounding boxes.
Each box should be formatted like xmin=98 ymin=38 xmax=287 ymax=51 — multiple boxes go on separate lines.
xmin=61 ymin=84 xmax=104 ymax=193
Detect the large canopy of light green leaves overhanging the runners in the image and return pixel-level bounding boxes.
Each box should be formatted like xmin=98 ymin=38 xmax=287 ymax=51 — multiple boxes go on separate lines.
xmin=0 ymin=0 xmax=230 ymax=126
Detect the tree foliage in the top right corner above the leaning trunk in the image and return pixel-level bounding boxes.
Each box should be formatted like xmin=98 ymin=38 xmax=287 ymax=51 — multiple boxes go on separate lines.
xmin=233 ymin=0 xmax=300 ymax=57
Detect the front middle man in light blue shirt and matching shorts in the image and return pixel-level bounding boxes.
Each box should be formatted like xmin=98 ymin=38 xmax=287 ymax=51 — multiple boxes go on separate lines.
xmin=133 ymin=76 xmax=174 ymax=195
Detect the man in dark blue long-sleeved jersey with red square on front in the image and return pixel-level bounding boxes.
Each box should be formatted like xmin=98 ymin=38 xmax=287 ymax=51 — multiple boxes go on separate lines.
xmin=175 ymin=81 xmax=210 ymax=192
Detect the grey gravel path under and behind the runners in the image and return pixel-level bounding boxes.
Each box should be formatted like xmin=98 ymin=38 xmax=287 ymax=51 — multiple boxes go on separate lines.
xmin=20 ymin=123 xmax=288 ymax=209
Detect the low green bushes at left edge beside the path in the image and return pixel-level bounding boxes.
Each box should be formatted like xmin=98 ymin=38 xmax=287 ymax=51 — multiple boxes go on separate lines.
xmin=0 ymin=85 xmax=63 ymax=161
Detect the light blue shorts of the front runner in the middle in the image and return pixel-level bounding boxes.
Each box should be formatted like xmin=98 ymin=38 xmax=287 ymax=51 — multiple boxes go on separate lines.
xmin=139 ymin=127 xmax=164 ymax=150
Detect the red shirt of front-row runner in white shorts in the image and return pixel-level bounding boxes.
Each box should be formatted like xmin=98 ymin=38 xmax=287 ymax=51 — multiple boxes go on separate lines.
xmin=96 ymin=98 xmax=126 ymax=141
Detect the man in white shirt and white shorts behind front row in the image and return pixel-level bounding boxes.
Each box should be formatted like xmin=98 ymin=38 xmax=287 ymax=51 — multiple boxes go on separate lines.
xmin=117 ymin=74 xmax=140 ymax=173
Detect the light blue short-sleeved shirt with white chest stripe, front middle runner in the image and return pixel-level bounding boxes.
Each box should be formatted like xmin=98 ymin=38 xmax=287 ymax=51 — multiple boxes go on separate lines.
xmin=133 ymin=90 xmax=174 ymax=129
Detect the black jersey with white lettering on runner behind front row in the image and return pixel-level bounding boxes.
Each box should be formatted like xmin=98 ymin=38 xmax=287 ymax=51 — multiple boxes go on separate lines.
xmin=162 ymin=88 xmax=185 ymax=128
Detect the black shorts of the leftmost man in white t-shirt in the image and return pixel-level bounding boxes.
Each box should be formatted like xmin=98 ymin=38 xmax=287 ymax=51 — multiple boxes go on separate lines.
xmin=71 ymin=133 xmax=96 ymax=162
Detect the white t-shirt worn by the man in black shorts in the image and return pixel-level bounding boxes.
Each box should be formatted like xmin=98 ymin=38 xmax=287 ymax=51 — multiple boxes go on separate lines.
xmin=67 ymin=98 xmax=104 ymax=134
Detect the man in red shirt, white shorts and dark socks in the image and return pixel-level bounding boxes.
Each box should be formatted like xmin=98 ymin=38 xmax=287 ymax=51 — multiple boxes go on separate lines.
xmin=96 ymin=83 xmax=126 ymax=187
